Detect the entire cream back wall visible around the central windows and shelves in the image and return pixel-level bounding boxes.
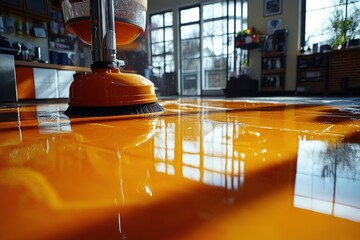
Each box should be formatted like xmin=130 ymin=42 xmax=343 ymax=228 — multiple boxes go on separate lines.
xmin=148 ymin=0 xmax=301 ymax=91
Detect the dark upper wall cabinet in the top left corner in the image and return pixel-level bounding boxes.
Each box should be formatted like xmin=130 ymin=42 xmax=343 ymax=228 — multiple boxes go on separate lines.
xmin=0 ymin=0 xmax=50 ymax=20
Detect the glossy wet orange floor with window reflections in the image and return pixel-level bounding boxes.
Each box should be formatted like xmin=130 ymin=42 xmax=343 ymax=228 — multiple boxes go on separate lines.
xmin=0 ymin=98 xmax=360 ymax=239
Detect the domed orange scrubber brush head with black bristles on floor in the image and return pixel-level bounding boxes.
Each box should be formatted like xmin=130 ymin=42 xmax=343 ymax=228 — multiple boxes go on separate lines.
xmin=65 ymin=68 xmax=164 ymax=116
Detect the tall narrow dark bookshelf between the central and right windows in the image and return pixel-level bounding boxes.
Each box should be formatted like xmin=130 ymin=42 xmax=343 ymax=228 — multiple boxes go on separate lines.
xmin=260 ymin=29 xmax=288 ymax=92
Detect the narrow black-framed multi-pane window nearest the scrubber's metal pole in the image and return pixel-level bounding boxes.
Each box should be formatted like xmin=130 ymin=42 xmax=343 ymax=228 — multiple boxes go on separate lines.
xmin=150 ymin=11 xmax=175 ymax=76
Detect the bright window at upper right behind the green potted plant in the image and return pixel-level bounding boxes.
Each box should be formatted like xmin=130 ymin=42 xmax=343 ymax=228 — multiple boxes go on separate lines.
xmin=302 ymin=0 xmax=360 ymax=46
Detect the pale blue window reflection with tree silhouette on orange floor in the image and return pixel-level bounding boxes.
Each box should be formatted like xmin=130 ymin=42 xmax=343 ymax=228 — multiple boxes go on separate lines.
xmin=294 ymin=139 xmax=360 ymax=222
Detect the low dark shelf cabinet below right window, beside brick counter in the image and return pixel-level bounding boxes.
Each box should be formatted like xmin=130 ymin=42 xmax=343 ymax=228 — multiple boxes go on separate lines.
xmin=296 ymin=53 xmax=329 ymax=94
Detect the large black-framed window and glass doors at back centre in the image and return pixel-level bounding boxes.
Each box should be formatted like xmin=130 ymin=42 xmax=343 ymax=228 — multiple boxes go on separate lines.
xmin=179 ymin=0 xmax=247 ymax=95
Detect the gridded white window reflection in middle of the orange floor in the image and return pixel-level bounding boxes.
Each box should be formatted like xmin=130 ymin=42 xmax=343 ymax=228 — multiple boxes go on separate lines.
xmin=154 ymin=117 xmax=245 ymax=190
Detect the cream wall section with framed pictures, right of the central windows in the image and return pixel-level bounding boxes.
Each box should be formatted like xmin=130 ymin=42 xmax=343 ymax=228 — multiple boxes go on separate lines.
xmin=248 ymin=0 xmax=301 ymax=91
